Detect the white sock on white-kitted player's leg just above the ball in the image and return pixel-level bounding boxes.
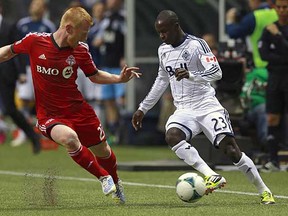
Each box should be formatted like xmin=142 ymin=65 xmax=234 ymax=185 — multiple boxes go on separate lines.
xmin=172 ymin=140 xmax=217 ymax=176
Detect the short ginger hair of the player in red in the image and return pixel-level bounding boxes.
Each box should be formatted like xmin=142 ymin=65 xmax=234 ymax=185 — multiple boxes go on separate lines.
xmin=60 ymin=7 xmax=93 ymax=27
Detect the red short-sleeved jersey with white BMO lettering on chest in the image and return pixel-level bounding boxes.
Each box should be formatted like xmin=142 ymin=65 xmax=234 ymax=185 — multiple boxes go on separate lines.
xmin=12 ymin=33 xmax=97 ymax=120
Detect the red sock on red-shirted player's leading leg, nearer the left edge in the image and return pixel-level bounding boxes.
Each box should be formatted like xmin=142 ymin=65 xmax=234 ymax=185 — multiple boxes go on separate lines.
xmin=68 ymin=146 xmax=109 ymax=178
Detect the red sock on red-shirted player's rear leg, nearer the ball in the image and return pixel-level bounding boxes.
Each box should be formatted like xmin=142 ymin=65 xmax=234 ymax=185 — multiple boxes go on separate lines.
xmin=96 ymin=149 xmax=119 ymax=183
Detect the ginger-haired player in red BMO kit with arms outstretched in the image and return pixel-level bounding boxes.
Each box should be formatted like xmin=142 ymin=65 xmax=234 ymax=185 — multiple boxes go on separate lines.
xmin=0 ymin=7 xmax=141 ymax=203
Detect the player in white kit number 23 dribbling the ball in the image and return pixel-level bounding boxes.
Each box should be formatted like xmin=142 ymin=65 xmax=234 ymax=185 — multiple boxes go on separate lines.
xmin=132 ymin=10 xmax=275 ymax=204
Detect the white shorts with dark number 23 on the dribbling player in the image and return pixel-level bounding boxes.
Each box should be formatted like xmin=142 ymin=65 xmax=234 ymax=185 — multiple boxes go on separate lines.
xmin=166 ymin=107 xmax=234 ymax=147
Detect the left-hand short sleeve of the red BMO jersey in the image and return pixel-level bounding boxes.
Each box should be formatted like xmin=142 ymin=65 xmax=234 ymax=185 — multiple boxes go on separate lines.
xmin=12 ymin=33 xmax=36 ymax=54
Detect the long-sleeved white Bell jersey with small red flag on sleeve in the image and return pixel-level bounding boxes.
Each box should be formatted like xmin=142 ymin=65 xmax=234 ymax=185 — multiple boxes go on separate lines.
xmin=139 ymin=35 xmax=223 ymax=114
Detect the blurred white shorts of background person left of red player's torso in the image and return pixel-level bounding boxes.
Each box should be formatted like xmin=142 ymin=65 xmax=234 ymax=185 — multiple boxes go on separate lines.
xmin=17 ymin=65 xmax=34 ymax=101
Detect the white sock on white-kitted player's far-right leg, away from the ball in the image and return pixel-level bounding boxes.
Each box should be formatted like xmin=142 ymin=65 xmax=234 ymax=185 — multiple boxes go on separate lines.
xmin=234 ymin=152 xmax=271 ymax=194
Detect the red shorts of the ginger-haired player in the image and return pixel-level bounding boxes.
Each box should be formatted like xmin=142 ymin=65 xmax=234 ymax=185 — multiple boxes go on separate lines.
xmin=37 ymin=115 xmax=106 ymax=147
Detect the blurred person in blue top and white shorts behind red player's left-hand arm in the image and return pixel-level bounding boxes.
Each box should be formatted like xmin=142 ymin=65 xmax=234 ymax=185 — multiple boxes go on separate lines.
xmin=14 ymin=0 xmax=56 ymax=145
